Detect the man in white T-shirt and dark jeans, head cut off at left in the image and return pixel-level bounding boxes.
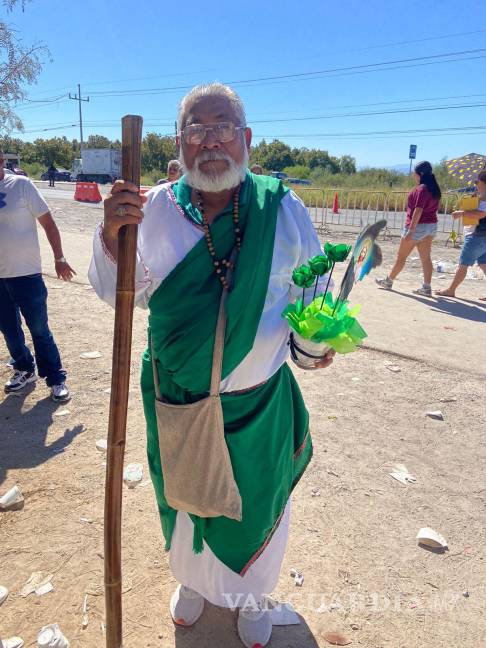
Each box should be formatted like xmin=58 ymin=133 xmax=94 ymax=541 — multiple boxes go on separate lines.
xmin=0 ymin=151 xmax=76 ymax=402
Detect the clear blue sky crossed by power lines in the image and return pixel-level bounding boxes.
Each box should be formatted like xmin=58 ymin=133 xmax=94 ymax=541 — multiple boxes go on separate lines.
xmin=6 ymin=0 xmax=486 ymax=166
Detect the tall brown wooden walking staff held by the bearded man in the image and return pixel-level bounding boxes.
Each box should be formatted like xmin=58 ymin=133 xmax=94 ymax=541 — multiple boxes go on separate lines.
xmin=105 ymin=115 xmax=142 ymax=648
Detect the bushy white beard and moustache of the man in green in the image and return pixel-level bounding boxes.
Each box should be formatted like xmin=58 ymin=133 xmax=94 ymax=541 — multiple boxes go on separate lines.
xmin=179 ymin=146 xmax=249 ymax=193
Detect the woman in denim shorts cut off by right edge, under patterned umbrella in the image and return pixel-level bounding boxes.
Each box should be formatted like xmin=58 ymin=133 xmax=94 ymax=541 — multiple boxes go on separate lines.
xmin=435 ymin=169 xmax=486 ymax=301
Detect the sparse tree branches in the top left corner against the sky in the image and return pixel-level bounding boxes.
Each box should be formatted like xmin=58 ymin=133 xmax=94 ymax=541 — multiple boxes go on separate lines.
xmin=0 ymin=0 xmax=49 ymax=133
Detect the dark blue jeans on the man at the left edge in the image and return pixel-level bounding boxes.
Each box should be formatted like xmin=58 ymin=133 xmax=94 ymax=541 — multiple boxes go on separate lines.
xmin=0 ymin=274 xmax=66 ymax=387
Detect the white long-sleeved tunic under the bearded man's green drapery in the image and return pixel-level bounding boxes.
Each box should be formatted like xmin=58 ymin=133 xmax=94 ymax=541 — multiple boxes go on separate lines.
xmin=89 ymin=185 xmax=332 ymax=607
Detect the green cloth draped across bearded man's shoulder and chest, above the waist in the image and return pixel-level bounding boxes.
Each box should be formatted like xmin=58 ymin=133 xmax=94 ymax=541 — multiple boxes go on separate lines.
xmin=149 ymin=174 xmax=288 ymax=394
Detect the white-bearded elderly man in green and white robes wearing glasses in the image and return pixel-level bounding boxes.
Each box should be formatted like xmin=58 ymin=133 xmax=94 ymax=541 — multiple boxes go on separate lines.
xmin=90 ymin=83 xmax=333 ymax=648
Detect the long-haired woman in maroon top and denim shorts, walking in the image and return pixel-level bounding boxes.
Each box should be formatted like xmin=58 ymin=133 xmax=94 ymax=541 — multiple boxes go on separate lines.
xmin=376 ymin=162 xmax=442 ymax=297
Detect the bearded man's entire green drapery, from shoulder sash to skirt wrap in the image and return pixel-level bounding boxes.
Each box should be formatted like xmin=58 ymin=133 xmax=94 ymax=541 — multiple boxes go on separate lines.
xmin=142 ymin=174 xmax=312 ymax=574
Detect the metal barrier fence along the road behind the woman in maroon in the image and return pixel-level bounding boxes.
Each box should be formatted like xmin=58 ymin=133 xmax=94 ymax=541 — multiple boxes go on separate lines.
xmin=297 ymin=187 xmax=462 ymax=242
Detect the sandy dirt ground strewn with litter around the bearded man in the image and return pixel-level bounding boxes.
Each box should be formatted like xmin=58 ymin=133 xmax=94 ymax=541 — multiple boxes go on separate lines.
xmin=0 ymin=194 xmax=486 ymax=648
